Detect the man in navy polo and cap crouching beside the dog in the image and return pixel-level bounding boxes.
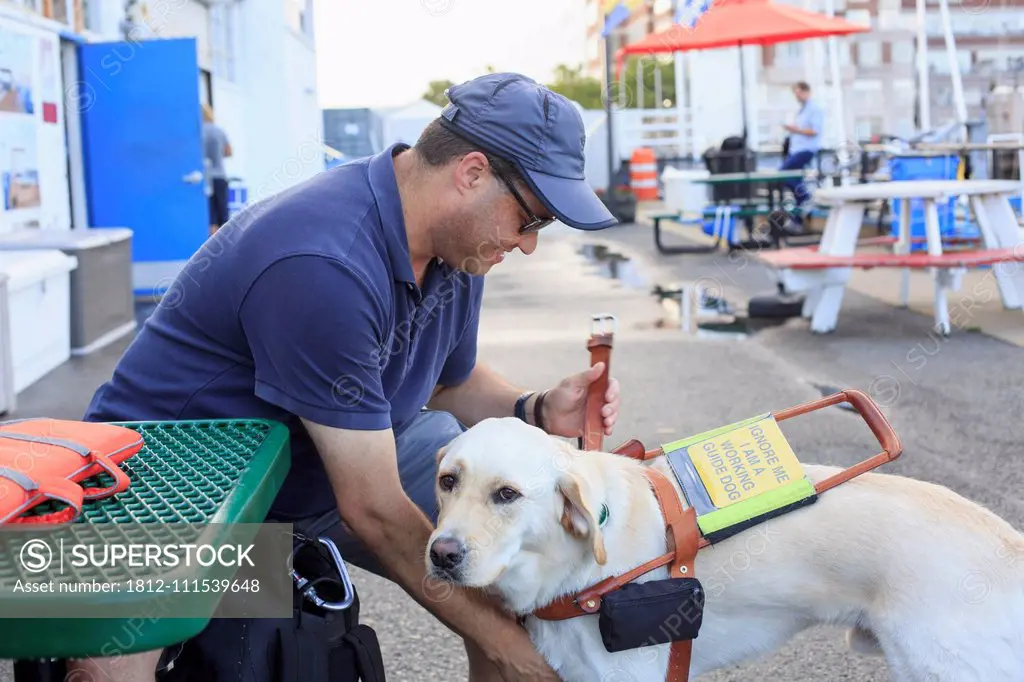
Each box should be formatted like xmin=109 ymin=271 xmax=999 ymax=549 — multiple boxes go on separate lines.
xmin=72 ymin=74 xmax=618 ymax=682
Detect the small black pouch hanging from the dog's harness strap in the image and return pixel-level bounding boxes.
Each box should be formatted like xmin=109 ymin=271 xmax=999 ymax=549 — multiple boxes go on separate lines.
xmin=598 ymin=578 xmax=705 ymax=652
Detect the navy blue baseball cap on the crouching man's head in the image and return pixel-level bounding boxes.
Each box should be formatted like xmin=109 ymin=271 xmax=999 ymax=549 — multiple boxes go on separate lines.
xmin=440 ymin=74 xmax=618 ymax=229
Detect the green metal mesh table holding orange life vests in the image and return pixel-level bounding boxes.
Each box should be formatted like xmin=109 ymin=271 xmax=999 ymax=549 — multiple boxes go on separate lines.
xmin=0 ymin=420 xmax=291 ymax=682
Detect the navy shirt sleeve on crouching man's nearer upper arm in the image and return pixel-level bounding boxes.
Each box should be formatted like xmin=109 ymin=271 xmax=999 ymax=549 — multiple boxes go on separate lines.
xmin=239 ymin=255 xmax=391 ymax=430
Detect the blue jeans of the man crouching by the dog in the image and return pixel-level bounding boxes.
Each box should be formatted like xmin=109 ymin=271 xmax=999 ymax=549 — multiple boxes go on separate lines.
xmin=294 ymin=410 xmax=466 ymax=578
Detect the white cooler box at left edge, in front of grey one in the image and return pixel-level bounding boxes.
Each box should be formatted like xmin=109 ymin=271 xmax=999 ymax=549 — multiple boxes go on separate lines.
xmin=0 ymin=250 xmax=78 ymax=394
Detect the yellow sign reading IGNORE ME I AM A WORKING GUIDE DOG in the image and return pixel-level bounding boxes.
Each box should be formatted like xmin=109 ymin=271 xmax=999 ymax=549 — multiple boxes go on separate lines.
xmin=687 ymin=415 xmax=804 ymax=508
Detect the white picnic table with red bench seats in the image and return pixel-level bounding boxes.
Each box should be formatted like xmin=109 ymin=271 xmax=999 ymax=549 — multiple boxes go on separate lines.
xmin=764 ymin=180 xmax=1024 ymax=334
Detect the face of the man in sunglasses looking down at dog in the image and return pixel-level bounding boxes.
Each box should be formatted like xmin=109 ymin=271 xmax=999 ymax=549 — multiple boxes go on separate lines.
xmin=436 ymin=152 xmax=551 ymax=274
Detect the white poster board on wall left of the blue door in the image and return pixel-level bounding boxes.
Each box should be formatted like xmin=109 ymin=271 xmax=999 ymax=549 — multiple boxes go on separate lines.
xmin=0 ymin=13 xmax=71 ymax=231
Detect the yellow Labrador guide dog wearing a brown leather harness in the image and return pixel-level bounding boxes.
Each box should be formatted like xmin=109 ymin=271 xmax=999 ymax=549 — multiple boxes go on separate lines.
xmin=426 ymin=418 xmax=1024 ymax=682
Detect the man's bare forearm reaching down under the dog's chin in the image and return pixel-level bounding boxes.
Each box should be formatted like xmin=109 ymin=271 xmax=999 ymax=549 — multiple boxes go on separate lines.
xmin=303 ymin=420 xmax=556 ymax=680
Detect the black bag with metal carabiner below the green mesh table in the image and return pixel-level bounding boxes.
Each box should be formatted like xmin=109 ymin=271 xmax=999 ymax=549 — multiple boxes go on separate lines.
xmin=157 ymin=536 xmax=385 ymax=682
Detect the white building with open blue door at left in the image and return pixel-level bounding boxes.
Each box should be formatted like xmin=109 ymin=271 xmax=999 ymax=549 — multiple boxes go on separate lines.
xmin=0 ymin=0 xmax=324 ymax=293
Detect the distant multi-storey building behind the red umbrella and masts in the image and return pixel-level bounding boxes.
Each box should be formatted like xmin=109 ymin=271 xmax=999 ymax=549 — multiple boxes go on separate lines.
xmin=581 ymin=0 xmax=1024 ymax=150
